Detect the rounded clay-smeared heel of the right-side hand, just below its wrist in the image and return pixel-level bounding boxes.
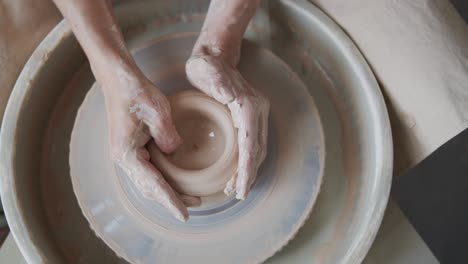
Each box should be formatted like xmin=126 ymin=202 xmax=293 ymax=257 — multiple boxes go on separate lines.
xmin=185 ymin=55 xmax=235 ymax=104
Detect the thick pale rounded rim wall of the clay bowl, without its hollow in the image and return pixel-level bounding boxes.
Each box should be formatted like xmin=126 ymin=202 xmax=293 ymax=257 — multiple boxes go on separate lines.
xmin=150 ymin=90 xmax=238 ymax=196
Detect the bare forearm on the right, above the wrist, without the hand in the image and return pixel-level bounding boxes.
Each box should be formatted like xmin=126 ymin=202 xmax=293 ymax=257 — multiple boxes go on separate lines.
xmin=192 ymin=0 xmax=261 ymax=66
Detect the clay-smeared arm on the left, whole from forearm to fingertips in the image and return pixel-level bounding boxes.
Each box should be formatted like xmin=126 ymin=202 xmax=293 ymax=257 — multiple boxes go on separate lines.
xmin=54 ymin=0 xmax=200 ymax=221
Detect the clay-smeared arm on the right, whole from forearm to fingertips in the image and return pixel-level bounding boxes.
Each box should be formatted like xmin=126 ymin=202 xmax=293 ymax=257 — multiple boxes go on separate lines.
xmin=186 ymin=0 xmax=270 ymax=199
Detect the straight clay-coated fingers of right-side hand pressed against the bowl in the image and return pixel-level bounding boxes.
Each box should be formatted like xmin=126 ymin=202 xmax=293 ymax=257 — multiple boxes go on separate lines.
xmin=228 ymin=99 xmax=259 ymax=200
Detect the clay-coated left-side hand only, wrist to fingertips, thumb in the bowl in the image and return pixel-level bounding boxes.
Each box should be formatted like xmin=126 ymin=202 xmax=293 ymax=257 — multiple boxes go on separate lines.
xmin=103 ymin=73 xmax=194 ymax=221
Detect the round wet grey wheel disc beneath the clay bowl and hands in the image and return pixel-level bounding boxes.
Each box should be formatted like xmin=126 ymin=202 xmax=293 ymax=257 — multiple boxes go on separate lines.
xmin=70 ymin=34 xmax=325 ymax=263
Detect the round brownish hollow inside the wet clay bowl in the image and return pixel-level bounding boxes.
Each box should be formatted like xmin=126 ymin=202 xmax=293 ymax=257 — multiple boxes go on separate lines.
xmin=168 ymin=111 xmax=226 ymax=170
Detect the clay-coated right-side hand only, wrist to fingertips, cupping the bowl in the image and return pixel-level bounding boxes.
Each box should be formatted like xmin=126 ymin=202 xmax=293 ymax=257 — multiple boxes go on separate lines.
xmin=186 ymin=54 xmax=269 ymax=200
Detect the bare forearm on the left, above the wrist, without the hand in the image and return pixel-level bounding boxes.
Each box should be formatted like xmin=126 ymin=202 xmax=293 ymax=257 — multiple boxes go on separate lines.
xmin=54 ymin=0 xmax=142 ymax=88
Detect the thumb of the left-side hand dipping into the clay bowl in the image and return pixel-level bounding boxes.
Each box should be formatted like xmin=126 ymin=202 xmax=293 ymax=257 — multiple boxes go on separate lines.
xmin=147 ymin=116 xmax=182 ymax=153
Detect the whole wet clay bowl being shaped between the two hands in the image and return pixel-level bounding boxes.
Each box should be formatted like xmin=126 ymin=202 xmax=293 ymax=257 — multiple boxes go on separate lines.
xmin=149 ymin=90 xmax=238 ymax=196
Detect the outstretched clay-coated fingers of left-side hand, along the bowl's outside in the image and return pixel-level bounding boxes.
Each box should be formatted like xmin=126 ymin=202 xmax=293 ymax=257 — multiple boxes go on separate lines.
xmin=119 ymin=148 xmax=189 ymax=222
